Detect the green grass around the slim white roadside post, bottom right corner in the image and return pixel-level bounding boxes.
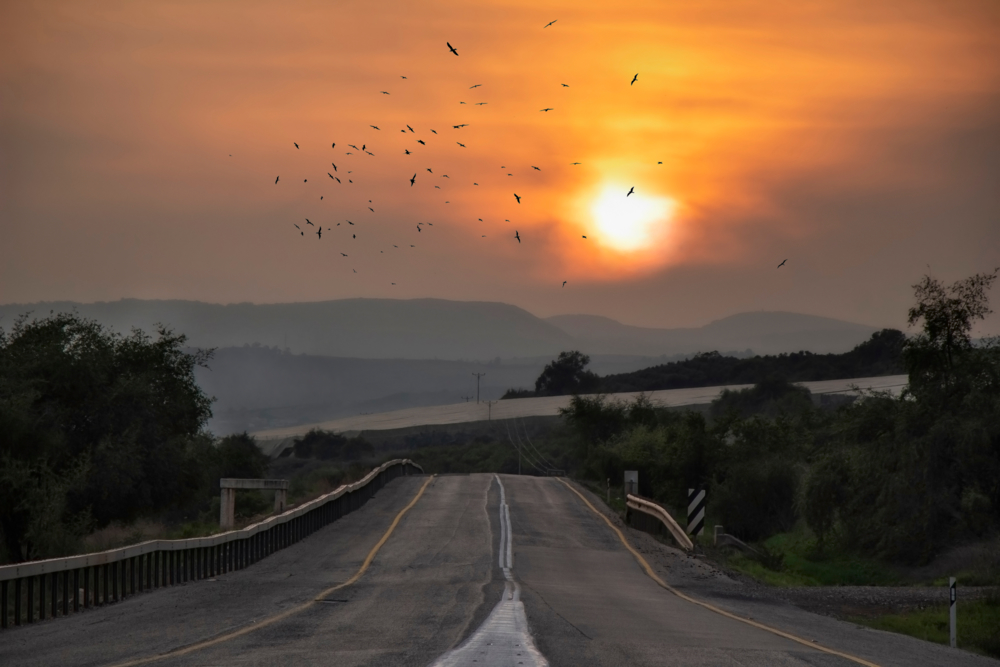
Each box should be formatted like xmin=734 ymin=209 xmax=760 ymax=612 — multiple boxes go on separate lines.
xmin=850 ymin=595 xmax=1000 ymax=658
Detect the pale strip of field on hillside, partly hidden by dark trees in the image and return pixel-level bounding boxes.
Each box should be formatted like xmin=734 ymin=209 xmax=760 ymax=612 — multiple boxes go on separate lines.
xmin=253 ymin=375 xmax=908 ymax=452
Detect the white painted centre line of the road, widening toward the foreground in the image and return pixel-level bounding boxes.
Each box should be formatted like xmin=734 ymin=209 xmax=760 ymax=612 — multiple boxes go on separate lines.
xmin=432 ymin=475 xmax=549 ymax=667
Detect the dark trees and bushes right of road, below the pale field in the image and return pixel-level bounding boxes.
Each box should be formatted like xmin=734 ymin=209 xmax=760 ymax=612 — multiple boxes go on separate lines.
xmin=564 ymin=272 xmax=1000 ymax=563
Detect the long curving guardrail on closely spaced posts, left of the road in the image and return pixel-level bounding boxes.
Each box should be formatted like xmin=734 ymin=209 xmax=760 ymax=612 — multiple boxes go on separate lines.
xmin=0 ymin=459 xmax=424 ymax=628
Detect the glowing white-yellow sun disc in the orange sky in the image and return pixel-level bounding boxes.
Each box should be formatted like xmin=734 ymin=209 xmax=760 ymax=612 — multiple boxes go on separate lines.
xmin=591 ymin=185 xmax=677 ymax=252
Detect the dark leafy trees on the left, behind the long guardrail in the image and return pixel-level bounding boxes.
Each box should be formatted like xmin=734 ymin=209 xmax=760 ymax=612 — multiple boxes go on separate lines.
xmin=0 ymin=314 xmax=267 ymax=562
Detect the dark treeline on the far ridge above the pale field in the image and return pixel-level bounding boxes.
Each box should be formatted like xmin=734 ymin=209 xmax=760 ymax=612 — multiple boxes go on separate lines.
xmin=504 ymin=329 xmax=906 ymax=398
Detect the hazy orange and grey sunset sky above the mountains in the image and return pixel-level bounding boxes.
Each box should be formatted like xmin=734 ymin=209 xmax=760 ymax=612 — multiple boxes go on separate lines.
xmin=0 ymin=0 xmax=1000 ymax=334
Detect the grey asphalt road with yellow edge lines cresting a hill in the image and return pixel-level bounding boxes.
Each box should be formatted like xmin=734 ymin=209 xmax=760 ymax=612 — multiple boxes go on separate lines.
xmin=0 ymin=475 xmax=1000 ymax=667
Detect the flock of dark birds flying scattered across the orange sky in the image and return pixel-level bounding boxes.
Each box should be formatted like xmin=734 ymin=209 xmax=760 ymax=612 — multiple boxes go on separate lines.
xmin=264 ymin=21 xmax=787 ymax=287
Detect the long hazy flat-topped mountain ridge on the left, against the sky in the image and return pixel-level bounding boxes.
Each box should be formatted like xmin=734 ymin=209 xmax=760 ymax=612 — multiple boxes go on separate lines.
xmin=0 ymin=299 xmax=574 ymax=359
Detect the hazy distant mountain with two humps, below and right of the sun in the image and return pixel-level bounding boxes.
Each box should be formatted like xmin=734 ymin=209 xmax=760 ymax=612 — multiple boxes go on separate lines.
xmin=546 ymin=312 xmax=878 ymax=356
